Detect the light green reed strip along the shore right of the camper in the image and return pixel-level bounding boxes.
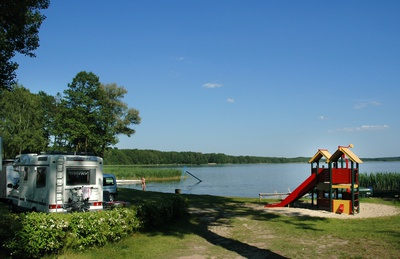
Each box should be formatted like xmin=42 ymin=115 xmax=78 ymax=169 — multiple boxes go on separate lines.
xmin=104 ymin=165 xmax=182 ymax=181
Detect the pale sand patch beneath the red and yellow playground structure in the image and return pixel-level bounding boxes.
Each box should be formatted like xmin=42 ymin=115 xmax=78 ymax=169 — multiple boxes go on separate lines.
xmin=254 ymin=203 xmax=400 ymax=219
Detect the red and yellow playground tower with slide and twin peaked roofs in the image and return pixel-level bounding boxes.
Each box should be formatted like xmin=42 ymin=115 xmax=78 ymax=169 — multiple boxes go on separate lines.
xmin=265 ymin=144 xmax=362 ymax=215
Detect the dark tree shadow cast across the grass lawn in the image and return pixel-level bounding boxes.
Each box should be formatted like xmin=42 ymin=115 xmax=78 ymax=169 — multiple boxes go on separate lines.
xmin=121 ymin=190 xmax=324 ymax=258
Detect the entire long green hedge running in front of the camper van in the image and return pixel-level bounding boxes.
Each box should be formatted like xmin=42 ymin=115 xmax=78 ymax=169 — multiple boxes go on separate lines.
xmin=0 ymin=196 xmax=187 ymax=258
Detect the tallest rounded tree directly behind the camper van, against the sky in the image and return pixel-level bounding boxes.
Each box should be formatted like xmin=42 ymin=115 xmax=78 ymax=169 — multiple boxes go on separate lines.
xmin=56 ymin=71 xmax=140 ymax=156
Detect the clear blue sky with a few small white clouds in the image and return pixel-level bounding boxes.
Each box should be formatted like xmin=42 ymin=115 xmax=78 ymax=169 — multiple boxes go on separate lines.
xmin=15 ymin=0 xmax=400 ymax=157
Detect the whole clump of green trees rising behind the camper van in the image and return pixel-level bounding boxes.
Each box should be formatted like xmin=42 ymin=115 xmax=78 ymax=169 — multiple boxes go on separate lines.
xmin=0 ymin=71 xmax=140 ymax=158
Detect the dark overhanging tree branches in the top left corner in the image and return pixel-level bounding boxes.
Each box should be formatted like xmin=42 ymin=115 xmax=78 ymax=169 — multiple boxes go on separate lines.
xmin=0 ymin=0 xmax=50 ymax=90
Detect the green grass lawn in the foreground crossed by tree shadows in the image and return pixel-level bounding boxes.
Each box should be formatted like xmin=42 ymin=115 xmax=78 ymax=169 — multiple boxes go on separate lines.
xmin=50 ymin=189 xmax=400 ymax=259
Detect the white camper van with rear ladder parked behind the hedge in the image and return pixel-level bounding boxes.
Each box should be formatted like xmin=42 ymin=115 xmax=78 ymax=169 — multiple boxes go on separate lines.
xmin=7 ymin=153 xmax=103 ymax=213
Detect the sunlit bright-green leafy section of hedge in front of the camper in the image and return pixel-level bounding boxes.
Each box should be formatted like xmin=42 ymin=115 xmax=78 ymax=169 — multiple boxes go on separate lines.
xmin=4 ymin=208 xmax=140 ymax=258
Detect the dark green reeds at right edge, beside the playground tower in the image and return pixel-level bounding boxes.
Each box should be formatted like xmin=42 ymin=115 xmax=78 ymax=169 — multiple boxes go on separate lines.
xmin=359 ymin=172 xmax=400 ymax=191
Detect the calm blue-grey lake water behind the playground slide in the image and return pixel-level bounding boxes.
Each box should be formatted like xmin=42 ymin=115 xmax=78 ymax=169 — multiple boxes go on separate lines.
xmin=123 ymin=162 xmax=400 ymax=198
